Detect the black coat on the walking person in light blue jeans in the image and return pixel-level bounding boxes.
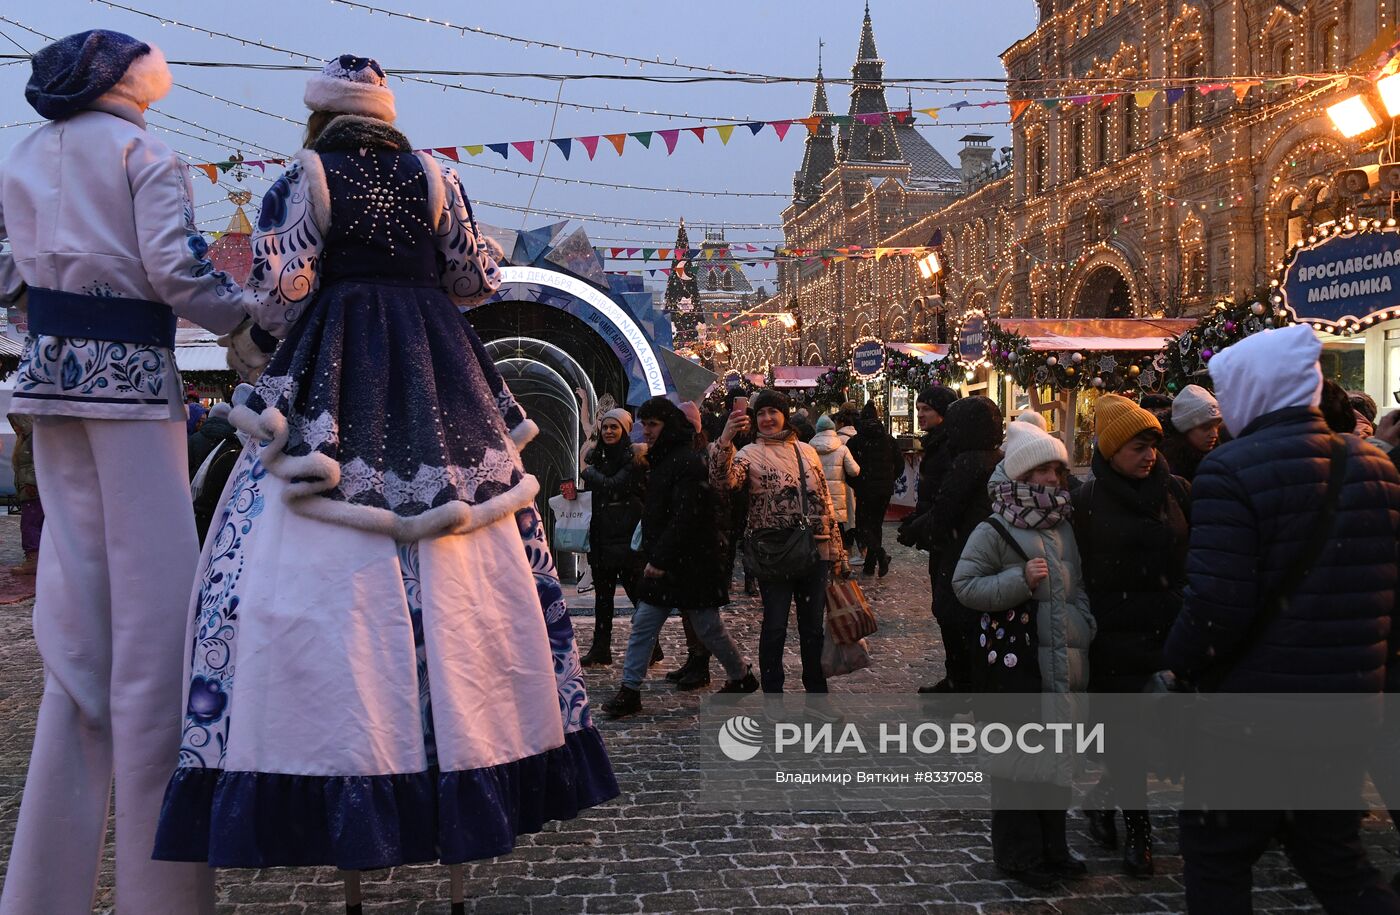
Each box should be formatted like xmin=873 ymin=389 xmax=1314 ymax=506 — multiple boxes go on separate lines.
xmin=637 ymin=407 xmax=729 ymax=607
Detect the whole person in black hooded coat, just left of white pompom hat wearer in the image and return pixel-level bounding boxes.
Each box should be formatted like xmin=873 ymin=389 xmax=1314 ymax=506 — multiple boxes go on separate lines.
xmin=921 ymin=397 xmax=1002 ymax=693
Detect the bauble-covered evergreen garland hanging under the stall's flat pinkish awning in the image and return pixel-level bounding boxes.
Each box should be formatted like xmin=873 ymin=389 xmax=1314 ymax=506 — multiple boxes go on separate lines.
xmin=987 ymin=322 xmax=1166 ymax=395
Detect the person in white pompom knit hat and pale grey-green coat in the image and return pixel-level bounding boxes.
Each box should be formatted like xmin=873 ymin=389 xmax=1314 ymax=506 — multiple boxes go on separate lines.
xmin=953 ymin=423 xmax=1095 ymax=888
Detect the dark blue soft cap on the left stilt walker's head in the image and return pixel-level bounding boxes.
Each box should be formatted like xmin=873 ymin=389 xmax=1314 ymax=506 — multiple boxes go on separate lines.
xmin=24 ymin=28 xmax=164 ymax=120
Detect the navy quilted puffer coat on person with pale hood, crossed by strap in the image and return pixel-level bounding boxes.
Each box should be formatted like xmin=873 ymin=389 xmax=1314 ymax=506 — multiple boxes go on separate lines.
xmin=1165 ymin=407 xmax=1400 ymax=693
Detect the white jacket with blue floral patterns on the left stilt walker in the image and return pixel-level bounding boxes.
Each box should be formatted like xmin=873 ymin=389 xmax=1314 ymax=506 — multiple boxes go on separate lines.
xmin=0 ymin=98 xmax=245 ymax=420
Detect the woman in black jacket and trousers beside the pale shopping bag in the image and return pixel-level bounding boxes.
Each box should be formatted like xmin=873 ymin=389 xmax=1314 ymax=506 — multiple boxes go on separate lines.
xmin=580 ymin=407 xmax=645 ymax=667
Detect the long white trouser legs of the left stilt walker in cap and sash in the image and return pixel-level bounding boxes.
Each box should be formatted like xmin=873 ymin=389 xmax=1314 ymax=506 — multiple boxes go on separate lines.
xmin=0 ymin=417 xmax=214 ymax=915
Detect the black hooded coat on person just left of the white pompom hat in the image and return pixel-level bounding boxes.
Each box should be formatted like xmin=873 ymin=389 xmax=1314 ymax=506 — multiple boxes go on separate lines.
xmin=928 ymin=397 xmax=1002 ymax=618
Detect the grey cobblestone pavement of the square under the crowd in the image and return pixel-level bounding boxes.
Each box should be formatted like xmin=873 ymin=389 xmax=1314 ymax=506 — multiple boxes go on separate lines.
xmin=0 ymin=518 xmax=1396 ymax=915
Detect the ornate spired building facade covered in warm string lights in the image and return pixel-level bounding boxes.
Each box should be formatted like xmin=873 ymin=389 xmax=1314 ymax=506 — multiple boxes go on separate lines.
xmin=729 ymin=0 xmax=1400 ymax=371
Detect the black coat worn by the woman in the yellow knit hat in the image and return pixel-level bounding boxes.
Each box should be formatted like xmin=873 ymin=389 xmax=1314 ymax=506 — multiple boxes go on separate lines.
xmin=1074 ymin=451 xmax=1191 ymax=693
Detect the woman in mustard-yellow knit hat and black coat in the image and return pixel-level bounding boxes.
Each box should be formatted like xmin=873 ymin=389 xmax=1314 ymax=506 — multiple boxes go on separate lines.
xmin=1074 ymin=395 xmax=1190 ymax=876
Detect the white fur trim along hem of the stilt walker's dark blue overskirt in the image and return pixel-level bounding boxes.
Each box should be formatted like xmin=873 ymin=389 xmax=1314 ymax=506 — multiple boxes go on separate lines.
xmin=228 ymin=404 xmax=539 ymax=543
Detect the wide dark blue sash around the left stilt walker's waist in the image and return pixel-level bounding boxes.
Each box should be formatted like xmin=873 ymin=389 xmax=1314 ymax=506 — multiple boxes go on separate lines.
xmin=29 ymin=285 xmax=175 ymax=348
